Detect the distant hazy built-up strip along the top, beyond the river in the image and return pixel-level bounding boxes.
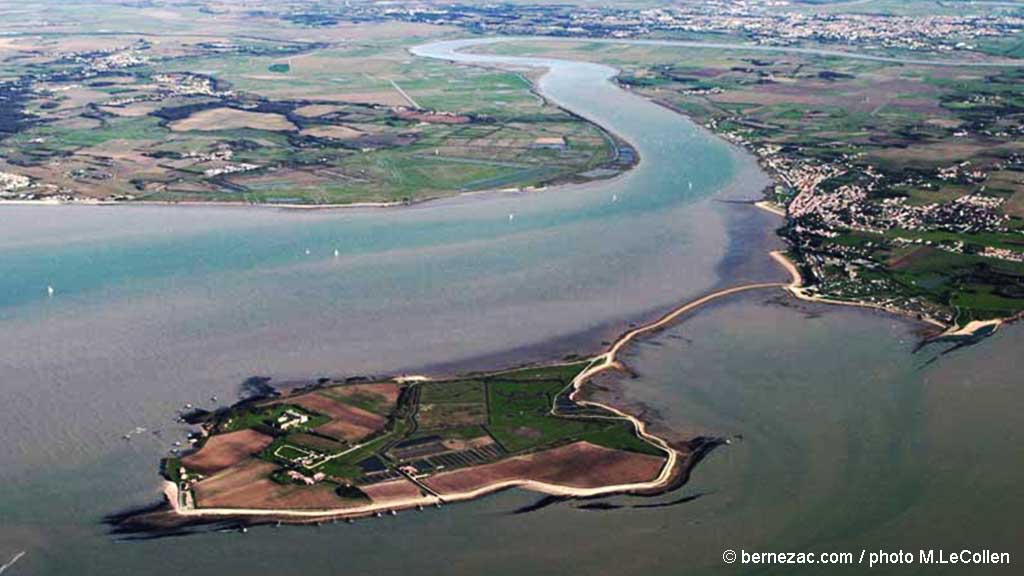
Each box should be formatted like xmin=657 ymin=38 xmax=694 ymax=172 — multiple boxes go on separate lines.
xmin=303 ymin=0 xmax=1024 ymax=51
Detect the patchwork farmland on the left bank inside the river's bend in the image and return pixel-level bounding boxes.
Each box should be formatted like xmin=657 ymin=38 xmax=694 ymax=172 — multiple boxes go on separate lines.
xmin=0 ymin=17 xmax=625 ymax=204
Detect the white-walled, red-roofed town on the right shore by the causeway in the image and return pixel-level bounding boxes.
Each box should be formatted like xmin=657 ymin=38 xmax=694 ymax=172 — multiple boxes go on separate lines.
xmin=712 ymin=117 xmax=1024 ymax=325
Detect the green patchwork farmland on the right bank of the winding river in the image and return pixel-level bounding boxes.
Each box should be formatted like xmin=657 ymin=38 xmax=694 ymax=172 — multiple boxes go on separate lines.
xmin=479 ymin=39 xmax=1024 ymax=325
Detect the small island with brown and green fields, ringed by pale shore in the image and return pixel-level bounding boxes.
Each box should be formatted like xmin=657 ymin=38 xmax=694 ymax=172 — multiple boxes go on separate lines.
xmin=115 ymin=356 xmax=717 ymax=532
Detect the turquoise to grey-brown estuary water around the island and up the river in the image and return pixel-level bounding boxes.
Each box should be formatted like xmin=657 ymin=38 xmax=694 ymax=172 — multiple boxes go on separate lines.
xmin=0 ymin=38 xmax=1022 ymax=574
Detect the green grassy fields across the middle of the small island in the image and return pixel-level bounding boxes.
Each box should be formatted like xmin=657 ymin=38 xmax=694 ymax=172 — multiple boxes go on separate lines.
xmin=178 ymin=362 xmax=663 ymax=494
